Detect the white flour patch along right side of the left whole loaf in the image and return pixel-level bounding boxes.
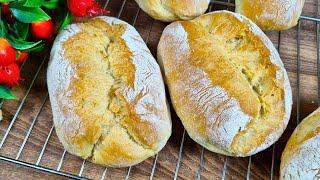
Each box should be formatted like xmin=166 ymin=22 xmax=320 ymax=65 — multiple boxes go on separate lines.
xmin=98 ymin=16 xmax=171 ymax=148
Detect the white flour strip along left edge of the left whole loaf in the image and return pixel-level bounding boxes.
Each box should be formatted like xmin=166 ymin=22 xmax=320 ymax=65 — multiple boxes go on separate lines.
xmin=47 ymin=24 xmax=81 ymax=151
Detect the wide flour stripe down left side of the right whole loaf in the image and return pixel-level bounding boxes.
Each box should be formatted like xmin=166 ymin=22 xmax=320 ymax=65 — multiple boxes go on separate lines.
xmin=163 ymin=22 xmax=251 ymax=152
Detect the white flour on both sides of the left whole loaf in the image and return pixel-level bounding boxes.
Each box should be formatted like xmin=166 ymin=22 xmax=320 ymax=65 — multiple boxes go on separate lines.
xmin=47 ymin=16 xmax=171 ymax=153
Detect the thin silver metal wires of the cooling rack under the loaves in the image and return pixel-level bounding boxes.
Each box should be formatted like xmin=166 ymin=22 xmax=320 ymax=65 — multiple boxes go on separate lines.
xmin=0 ymin=0 xmax=320 ymax=179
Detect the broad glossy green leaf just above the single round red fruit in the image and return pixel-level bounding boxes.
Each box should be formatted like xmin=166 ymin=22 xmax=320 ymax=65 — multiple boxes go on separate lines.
xmin=10 ymin=1 xmax=50 ymax=23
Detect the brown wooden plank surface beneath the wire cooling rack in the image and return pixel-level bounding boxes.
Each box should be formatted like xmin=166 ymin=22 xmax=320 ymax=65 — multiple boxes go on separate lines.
xmin=0 ymin=0 xmax=318 ymax=179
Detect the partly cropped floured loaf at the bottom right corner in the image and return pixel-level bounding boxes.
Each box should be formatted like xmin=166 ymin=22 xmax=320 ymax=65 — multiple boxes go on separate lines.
xmin=280 ymin=108 xmax=320 ymax=180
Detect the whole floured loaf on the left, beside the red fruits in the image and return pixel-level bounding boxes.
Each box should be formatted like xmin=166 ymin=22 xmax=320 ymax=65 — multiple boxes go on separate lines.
xmin=47 ymin=17 xmax=171 ymax=167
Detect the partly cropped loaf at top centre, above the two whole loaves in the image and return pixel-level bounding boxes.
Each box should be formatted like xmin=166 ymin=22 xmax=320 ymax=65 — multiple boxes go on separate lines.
xmin=136 ymin=0 xmax=210 ymax=22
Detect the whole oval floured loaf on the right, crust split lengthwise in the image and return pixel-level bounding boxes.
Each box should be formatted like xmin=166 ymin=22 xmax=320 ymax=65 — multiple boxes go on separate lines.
xmin=158 ymin=11 xmax=292 ymax=156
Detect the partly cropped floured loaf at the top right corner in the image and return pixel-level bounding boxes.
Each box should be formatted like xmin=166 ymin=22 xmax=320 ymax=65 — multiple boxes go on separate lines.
xmin=236 ymin=0 xmax=305 ymax=31
